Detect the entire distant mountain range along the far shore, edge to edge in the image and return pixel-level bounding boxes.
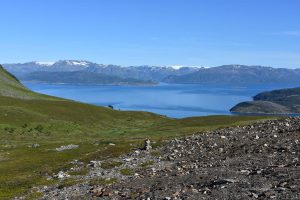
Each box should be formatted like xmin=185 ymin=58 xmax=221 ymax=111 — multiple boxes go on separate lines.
xmin=4 ymin=60 xmax=300 ymax=86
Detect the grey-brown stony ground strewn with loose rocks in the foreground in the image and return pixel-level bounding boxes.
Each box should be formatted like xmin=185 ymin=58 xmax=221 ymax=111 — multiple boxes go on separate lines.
xmin=40 ymin=117 xmax=300 ymax=199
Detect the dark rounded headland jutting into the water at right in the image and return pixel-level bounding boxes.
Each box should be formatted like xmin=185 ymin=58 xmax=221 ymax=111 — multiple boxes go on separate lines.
xmin=230 ymin=88 xmax=300 ymax=114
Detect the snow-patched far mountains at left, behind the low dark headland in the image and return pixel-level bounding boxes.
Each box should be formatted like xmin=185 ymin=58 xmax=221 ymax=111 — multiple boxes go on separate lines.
xmin=4 ymin=60 xmax=197 ymax=82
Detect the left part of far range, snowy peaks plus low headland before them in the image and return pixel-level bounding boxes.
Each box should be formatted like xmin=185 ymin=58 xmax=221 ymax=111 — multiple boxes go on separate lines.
xmin=3 ymin=60 xmax=198 ymax=85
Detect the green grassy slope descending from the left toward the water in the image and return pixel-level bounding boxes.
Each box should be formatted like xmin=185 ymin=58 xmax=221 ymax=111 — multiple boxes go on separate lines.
xmin=0 ymin=65 xmax=274 ymax=199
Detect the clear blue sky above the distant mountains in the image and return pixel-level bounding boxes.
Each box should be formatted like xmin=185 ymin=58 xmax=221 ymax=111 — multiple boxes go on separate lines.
xmin=0 ymin=0 xmax=300 ymax=68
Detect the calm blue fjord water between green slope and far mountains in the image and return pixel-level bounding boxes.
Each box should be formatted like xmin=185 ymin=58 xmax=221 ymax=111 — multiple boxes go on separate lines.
xmin=24 ymin=83 xmax=300 ymax=118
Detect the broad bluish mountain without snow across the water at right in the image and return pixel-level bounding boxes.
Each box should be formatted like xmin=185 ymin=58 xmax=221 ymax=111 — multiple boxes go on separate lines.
xmin=163 ymin=65 xmax=300 ymax=85
